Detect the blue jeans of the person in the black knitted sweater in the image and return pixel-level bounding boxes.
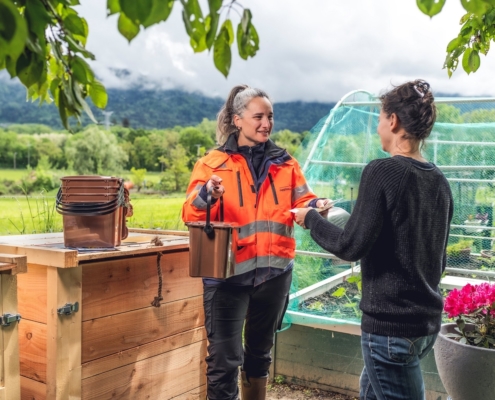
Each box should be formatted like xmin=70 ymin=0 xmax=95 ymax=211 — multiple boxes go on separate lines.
xmin=360 ymin=332 xmax=437 ymax=400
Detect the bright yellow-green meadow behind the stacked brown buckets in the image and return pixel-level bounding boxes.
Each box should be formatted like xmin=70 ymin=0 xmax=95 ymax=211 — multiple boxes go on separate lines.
xmin=0 ymin=194 xmax=186 ymax=235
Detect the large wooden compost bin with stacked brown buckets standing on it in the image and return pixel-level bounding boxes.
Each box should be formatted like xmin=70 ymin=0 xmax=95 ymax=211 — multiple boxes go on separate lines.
xmin=0 ymin=230 xmax=206 ymax=400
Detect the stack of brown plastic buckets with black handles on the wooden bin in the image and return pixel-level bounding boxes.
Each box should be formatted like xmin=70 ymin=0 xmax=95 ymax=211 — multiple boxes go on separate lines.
xmin=57 ymin=175 xmax=132 ymax=248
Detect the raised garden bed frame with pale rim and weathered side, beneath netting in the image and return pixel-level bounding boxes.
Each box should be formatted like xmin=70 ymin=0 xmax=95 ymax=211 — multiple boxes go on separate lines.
xmin=271 ymin=268 xmax=456 ymax=400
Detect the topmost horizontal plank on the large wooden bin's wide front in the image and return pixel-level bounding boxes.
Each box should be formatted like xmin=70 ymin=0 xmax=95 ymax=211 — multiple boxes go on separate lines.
xmin=82 ymin=252 xmax=203 ymax=321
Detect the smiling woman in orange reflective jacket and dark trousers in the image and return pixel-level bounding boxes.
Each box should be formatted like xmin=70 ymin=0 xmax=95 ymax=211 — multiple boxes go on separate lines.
xmin=182 ymin=85 xmax=329 ymax=400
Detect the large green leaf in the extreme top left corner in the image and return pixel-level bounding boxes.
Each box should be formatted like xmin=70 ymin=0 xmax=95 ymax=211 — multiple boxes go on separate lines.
xmin=0 ymin=0 xmax=28 ymax=60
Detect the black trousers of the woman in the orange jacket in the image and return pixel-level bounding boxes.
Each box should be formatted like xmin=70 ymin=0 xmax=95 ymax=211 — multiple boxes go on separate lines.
xmin=204 ymin=271 xmax=292 ymax=400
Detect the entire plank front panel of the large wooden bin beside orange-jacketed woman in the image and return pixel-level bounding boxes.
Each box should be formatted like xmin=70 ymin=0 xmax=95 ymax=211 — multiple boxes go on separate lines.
xmin=81 ymin=251 xmax=206 ymax=400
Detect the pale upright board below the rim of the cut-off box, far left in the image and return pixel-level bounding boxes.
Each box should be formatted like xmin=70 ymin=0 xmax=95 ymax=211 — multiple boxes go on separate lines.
xmin=0 ymin=275 xmax=21 ymax=400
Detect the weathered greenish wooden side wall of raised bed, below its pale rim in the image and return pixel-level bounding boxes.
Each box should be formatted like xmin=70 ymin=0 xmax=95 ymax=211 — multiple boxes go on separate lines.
xmin=273 ymin=325 xmax=447 ymax=400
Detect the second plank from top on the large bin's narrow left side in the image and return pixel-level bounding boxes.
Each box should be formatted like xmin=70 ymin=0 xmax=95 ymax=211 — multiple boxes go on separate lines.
xmin=19 ymin=319 xmax=46 ymax=383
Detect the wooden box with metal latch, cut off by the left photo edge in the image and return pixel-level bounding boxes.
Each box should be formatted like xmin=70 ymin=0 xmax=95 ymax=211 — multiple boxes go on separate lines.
xmin=0 ymin=254 xmax=27 ymax=400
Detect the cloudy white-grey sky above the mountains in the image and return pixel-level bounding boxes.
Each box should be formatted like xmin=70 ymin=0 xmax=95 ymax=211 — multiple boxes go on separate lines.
xmin=75 ymin=0 xmax=495 ymax=102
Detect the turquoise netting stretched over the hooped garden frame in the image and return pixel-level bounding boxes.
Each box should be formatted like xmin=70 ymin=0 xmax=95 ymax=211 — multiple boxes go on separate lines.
xmin=286 ymin=90 xmax=495 ymax=324
